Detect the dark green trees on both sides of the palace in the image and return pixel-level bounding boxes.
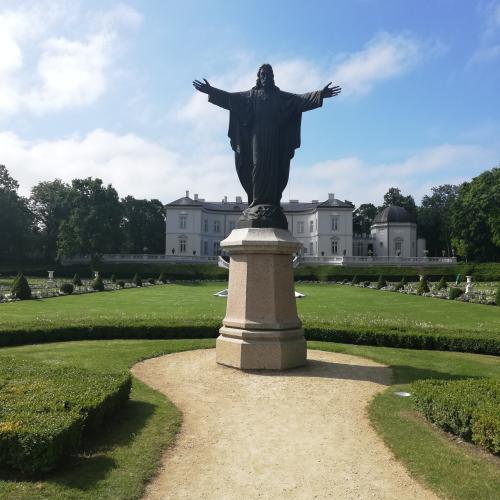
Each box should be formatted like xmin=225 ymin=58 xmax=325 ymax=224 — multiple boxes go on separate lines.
xmin=0 ymin=165 xmax=500 ymax=262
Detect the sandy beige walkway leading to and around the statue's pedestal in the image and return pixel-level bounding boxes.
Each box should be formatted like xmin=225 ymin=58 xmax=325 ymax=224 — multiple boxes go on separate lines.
xmin=132 ymin=349 xmax=435 ymax=500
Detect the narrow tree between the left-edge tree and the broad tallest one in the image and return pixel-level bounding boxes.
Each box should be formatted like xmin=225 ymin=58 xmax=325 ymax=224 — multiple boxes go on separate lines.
xmin=30 ymin=179 xmax=70 ymax=260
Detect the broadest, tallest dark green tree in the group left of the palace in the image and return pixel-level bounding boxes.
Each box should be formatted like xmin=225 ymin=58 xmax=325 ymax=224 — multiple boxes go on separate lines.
xmin=57 ymin=177 xmax=122 ymax=262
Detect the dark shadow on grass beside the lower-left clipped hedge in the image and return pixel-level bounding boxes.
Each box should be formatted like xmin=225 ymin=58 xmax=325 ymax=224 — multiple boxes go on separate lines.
xmin=0 ymin=400 xmax=156 ymax=491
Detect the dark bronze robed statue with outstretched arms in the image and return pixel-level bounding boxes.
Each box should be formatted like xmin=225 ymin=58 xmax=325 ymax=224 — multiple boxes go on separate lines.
xmin=193 ymin=64 xmax=341 ymax=229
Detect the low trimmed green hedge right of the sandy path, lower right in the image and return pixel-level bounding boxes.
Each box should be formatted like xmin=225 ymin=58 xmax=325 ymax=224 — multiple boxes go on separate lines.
xmin=411 ymin=379 xmax=500 ymax=454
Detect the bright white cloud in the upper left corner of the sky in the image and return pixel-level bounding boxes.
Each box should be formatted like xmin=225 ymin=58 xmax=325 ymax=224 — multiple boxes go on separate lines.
xmin=0 ymin=0 xmax=141 ymax=117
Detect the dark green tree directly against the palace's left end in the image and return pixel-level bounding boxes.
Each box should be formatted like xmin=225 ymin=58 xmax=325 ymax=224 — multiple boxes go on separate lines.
xmin=121 ymin=196 xmax=166 ymax=253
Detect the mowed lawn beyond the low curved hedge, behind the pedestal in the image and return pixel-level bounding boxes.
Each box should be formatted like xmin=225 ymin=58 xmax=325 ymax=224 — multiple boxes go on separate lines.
xmin=0 ymin=283 xmax=500 ymax=346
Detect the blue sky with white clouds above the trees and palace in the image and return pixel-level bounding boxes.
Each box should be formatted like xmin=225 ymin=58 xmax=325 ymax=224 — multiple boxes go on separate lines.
xmin=0 ymin=0 xmax=500 ymax=204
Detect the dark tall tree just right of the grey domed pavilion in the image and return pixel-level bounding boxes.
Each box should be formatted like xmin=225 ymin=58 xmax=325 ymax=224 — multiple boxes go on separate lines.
xmin=417 ymin=184 xmax=459 ymax=257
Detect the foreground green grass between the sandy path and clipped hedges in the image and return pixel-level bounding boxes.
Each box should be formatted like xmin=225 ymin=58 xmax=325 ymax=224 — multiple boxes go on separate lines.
xmin=0 ymin=340 xmax=500 ymax=499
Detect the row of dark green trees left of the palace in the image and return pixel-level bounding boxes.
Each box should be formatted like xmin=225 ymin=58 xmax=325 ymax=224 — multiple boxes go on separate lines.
xmin=0 ymin=165 xmax=165 ymax=262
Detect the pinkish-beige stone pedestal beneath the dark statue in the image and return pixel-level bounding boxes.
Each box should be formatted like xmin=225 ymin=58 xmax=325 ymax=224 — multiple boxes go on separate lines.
xmin=217 ymin=228 xmax=306 ymax=370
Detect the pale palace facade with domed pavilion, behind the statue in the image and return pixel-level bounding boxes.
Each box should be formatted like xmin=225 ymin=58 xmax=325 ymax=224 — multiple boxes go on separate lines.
xmin=165 ymin=191 xmax=425 ymax=259
